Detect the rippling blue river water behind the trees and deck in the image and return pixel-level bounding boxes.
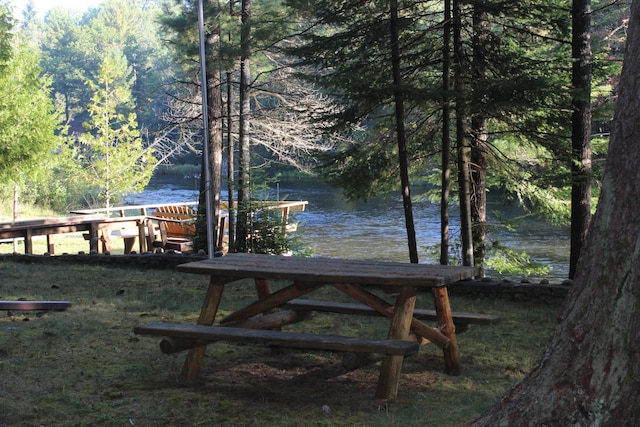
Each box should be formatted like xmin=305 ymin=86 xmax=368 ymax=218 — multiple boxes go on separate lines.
xmin=127 ymin=178 xmax=569 ymax=282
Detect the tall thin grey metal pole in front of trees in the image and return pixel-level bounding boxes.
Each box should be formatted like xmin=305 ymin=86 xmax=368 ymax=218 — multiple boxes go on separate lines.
xmin=198 ymin=0 xmax=214 ymax=259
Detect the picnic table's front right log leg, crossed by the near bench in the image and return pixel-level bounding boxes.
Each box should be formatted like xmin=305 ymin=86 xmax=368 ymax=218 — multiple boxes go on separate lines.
xmin=376 ymin=286 xmax=416 ymax=399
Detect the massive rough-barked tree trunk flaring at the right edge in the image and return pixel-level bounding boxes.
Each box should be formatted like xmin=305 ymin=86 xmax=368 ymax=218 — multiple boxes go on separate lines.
xmin=474 ymin=2 xmax=640 ymax=426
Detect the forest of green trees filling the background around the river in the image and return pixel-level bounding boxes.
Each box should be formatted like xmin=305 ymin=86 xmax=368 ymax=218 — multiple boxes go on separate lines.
xmin=0 ymin=0 xmax=631 ymax=275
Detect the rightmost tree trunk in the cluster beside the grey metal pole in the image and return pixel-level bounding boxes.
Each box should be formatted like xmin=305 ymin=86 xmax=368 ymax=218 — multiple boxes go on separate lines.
xmin=236 ymin=0 xmax=251 ymax=252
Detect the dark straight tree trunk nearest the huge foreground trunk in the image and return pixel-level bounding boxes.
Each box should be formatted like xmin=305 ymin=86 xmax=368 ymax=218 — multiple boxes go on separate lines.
xmin=569 ymin=0 xmax=591 ymax=279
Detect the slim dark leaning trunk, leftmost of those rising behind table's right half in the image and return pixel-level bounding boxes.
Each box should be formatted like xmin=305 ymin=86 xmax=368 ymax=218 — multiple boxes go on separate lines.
xmin=390 ymin=0 xmax=418 ymax=264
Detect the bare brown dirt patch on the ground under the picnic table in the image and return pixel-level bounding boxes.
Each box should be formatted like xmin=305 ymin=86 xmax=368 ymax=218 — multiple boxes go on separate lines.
xmin=188 ymin=349 xmax=442 ymax=408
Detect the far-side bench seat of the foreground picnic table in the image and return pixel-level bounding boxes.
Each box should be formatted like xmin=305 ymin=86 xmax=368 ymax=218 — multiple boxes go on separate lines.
xmin=284 ymin=299 xmax=500 ymax=328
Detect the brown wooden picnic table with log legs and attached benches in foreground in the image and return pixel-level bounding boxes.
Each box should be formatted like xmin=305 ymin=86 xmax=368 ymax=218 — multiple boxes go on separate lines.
xmin=134 ymin=254 xmax=480 ymax=399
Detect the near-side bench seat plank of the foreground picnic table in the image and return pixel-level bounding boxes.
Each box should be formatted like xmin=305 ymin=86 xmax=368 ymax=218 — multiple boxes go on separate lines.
xmin=134 ymin=322 xmax=419 ymax=356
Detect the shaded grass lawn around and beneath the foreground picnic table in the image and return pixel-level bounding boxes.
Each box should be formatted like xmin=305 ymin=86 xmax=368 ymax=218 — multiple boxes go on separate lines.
xmin=0 ymin=261 xmax=559 ymax=427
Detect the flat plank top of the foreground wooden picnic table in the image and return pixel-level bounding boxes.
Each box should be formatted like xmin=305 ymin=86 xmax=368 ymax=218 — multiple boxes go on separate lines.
xmin=178 ymin=253 xmax=478 ymax=287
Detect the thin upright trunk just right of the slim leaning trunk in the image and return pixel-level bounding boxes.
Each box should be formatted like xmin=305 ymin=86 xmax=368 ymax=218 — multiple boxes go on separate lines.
xmin=440 ymin=0 xmax=451 ymax=265
